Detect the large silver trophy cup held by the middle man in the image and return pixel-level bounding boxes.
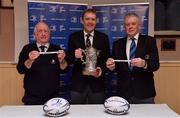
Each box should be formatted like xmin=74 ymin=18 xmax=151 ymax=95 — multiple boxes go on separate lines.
xmin=82 ymin=47 xmax=100 ymax=75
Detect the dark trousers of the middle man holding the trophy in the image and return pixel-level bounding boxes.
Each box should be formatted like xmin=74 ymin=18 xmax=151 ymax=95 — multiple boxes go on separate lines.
xmin=71 ymin=87 xmax=104 ymax=104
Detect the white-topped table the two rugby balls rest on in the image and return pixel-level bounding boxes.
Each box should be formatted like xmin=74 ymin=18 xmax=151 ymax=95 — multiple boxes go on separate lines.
xmin=0 ymin=104 xmax=180 ymax=118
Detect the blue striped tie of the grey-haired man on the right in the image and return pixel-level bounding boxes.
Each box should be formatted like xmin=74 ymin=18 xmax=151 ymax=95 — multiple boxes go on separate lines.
xmin=129 ymin=38 xmax=136 ymax=70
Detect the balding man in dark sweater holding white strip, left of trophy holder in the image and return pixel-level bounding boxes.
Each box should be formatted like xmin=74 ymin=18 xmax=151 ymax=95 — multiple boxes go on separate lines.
xmin=17 ymin=22 xmax=67 ymax=105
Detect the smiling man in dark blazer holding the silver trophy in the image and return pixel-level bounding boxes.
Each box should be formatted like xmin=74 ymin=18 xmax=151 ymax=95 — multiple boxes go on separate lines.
xmin=67 ymin=9 xmax=110 ymax=104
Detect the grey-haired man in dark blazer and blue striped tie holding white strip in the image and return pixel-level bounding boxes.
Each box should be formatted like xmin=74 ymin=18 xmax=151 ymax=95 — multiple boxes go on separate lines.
xmin=106 ymin=13 xmax=159 ymax=103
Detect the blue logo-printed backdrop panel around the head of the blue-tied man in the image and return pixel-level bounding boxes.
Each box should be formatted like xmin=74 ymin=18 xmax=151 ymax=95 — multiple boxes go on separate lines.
xmin=93 ymin=3 xmax=149 ymax=48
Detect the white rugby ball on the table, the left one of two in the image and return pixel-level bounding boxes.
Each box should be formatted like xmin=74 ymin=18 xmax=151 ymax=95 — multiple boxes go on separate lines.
xmin=43 ymin=98 xmax=70 ymax=117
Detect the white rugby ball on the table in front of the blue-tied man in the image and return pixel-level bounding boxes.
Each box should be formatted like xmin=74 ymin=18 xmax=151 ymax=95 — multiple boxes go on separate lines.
xmin=104 ymin=96 xmax=130 ymax=115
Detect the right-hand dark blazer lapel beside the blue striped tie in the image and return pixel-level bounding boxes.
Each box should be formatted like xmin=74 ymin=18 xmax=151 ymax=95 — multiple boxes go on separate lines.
xmin=135 ymin=34 xmax=145 ymax=57
